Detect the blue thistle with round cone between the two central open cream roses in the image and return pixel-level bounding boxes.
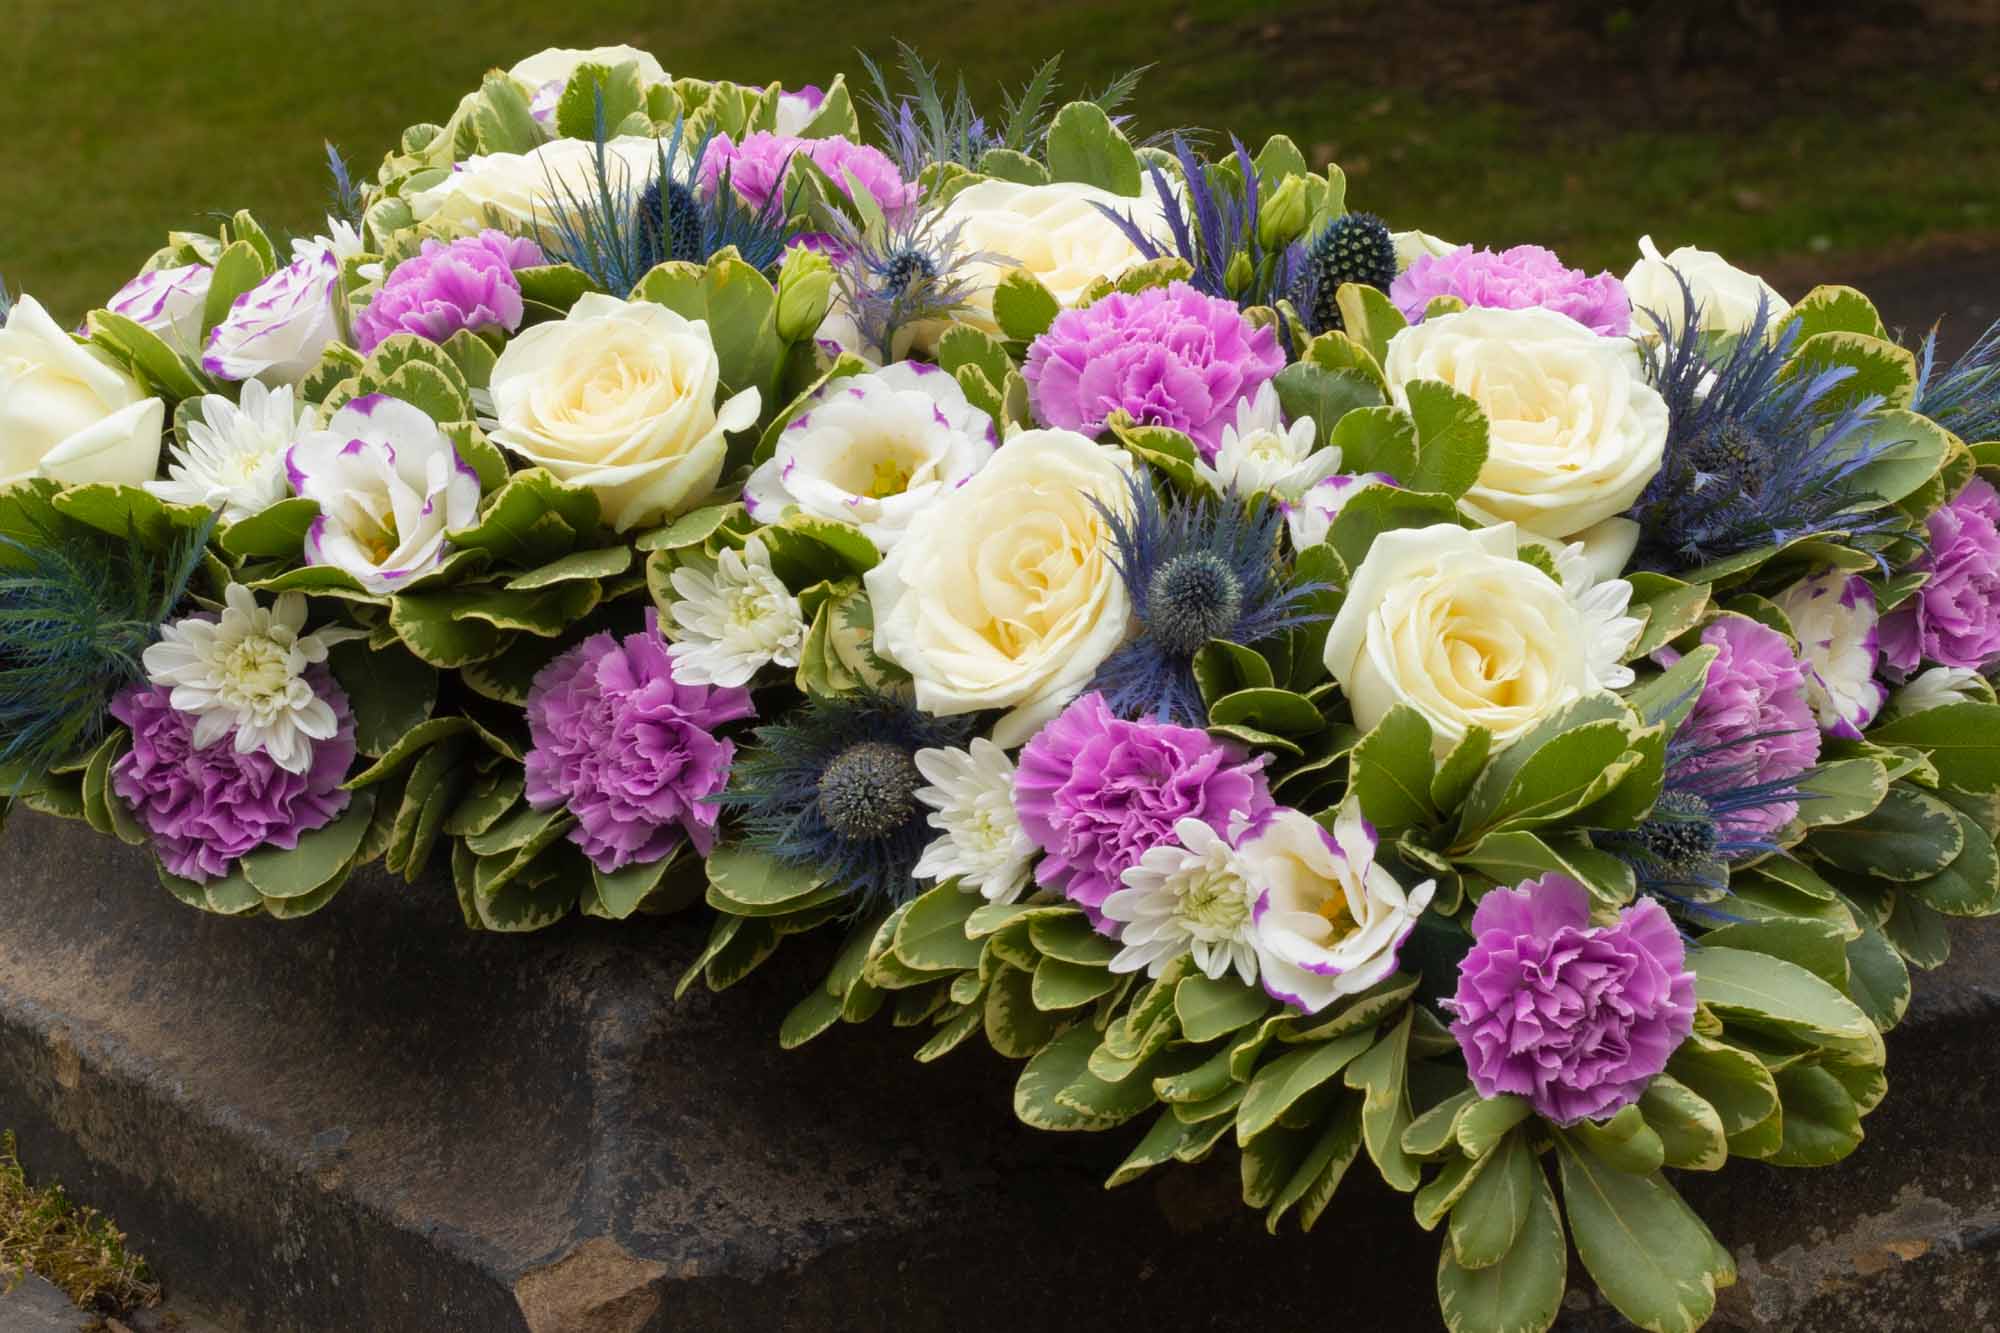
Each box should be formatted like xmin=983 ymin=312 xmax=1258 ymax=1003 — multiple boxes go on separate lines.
xmin=1090 ymin=476 xmax=1324 ymax=727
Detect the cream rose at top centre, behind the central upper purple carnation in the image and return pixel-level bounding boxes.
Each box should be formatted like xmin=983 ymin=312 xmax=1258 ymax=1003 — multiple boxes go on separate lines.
xmin=942 ymin=180 xmax=1162 ymax=332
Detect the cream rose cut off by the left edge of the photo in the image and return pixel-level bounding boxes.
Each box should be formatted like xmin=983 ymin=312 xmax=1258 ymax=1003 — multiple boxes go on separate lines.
xmin=0 ymin=296 xmax=166 ymax=490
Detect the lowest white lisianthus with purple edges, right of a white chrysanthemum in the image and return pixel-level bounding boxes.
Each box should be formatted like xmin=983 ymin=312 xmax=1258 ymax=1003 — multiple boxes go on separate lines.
xmin=1236 ymin=801 xmax=1438 ymax=1013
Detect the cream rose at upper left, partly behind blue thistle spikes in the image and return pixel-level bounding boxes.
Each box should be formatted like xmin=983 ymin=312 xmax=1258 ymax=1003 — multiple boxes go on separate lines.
xmin=408 ymin=134 xmax=660 ymax=246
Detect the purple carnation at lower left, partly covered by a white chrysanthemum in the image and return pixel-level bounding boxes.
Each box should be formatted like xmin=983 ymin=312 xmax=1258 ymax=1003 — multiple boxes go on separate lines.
xmin=112 ymin=669 xmax=354 ymax=885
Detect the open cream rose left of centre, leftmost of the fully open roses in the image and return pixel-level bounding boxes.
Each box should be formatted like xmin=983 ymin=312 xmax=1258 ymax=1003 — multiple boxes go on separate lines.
xmin=492 ymin=292 xmax=760 ymax=532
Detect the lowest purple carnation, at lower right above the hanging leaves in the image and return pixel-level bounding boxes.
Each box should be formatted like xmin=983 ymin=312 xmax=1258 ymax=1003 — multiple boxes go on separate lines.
xmin=1448 ymin=873 xmax=1694 ymax=1125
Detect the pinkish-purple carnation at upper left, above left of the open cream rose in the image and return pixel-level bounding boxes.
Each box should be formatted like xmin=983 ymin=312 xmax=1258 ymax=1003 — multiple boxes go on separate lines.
xmin=354 ymin=228 xmax=544 ymax=352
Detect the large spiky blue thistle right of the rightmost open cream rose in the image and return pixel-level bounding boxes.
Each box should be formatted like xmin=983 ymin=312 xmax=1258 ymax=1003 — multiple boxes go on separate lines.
xmin=1628 ymin=280 xmax=1894 ymax=572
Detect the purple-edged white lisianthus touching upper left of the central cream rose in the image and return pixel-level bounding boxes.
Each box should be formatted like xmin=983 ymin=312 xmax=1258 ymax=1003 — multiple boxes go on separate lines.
xmin=744 ymin=362 xmax=1000 ymax=550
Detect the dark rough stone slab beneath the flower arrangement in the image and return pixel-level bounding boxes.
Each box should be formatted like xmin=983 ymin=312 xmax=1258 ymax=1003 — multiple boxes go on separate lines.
xmin=0 ymin=817 xmax=2000 ymax=1333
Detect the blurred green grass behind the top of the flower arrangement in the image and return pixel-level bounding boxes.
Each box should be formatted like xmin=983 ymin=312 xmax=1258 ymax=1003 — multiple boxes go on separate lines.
xmin=0 ymin=0 xmax=2000 ymax=318
